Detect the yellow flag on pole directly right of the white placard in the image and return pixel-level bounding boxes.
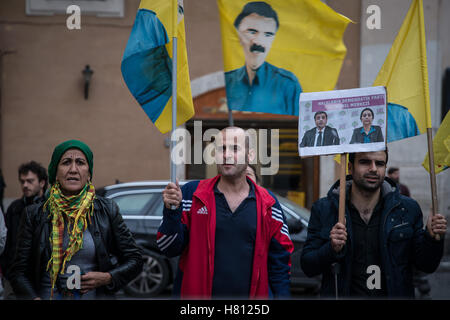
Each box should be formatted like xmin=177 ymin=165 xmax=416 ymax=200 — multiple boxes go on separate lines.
xmin=373 ymin=0 xmax=431 ymax=135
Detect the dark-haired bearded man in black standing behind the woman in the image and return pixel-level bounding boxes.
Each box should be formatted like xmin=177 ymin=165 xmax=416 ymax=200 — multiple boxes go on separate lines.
xmin=0 ymin=161 xmax=48 ymax=299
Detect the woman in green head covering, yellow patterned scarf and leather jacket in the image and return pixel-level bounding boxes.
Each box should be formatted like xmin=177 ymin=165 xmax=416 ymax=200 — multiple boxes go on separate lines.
xmin=11 ymin=140 xmax=143 ymax=299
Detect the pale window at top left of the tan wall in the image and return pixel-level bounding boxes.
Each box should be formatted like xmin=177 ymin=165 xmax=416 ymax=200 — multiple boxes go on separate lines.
xmin=25 ymin=0 xmax=124 ymax=18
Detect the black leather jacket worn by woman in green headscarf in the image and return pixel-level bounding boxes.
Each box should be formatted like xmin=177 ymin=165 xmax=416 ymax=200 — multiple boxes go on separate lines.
xmin=10 ymin=196 xmax=143 ymax=299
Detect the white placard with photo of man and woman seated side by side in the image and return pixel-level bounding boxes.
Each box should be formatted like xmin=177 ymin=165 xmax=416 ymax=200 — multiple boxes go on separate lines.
xmin=298 ymin=87 xmax=387 ymax=157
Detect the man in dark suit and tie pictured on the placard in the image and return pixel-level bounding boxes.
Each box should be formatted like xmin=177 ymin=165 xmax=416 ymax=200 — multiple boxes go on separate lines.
xmin=300 ymin=111 xmax=339 ymax=147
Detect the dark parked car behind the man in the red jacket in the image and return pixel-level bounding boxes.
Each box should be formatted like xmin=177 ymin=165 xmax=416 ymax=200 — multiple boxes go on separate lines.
xmin=101 ymin=181 xmax=320 ymax=298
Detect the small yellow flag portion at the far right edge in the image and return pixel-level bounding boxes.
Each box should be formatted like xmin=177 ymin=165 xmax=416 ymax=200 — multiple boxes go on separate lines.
xmin=422 ymin=112 xmax=450 ymax=174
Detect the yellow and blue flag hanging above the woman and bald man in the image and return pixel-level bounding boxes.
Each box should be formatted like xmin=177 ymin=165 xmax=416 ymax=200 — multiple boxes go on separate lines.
xmin=121 ymin=0 xmax=194 ymax=133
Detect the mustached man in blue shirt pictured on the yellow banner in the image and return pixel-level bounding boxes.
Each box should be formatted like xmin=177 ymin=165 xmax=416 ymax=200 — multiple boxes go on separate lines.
xmin=225 ymin=1 xmax=302 ymax=114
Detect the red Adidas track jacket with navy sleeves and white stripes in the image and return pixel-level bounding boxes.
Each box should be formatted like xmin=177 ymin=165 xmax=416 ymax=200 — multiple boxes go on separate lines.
xmin=157 ymin=176 xmax=294 ymax=298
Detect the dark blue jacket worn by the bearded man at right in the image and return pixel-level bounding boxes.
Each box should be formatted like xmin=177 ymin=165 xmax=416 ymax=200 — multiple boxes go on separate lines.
xmin=301 ymin=176 xmax=444 ymax=298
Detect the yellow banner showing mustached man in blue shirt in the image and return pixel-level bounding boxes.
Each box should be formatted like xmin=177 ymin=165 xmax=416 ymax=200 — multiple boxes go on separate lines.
xmin=218 ymin=0 xmax=350 ymax=115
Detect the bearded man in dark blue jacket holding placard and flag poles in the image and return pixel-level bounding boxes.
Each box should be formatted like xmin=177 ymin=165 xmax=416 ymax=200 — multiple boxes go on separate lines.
xmin=301 ymin=151 xmax=447 ymax=298
